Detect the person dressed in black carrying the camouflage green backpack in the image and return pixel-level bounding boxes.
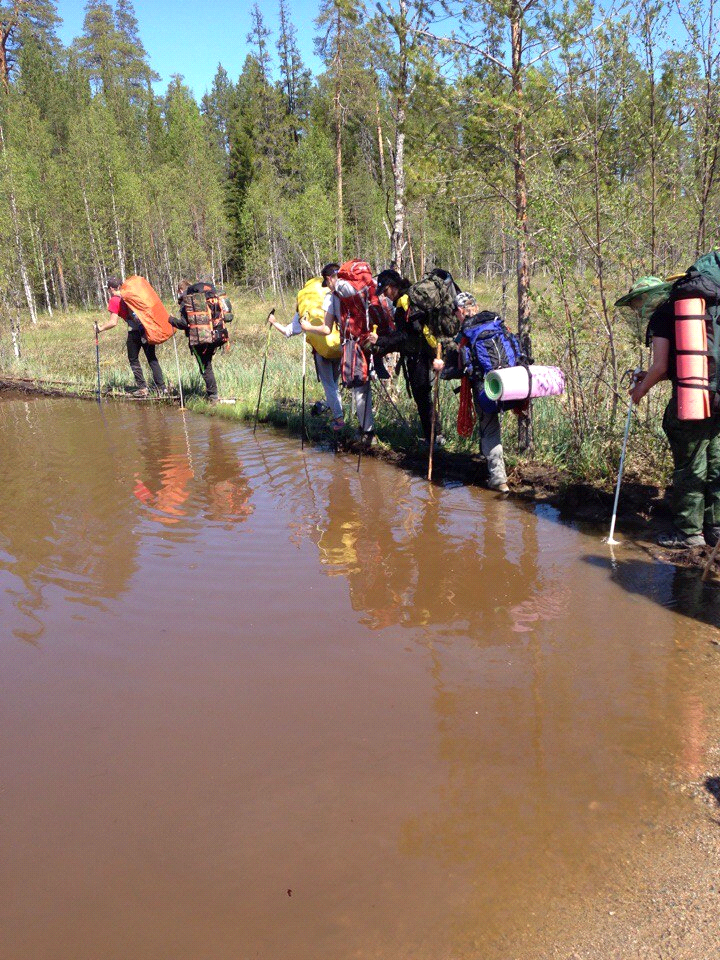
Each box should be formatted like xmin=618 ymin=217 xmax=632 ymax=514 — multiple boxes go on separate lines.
xmin=373 ymin=270 xmax=445 ymax=446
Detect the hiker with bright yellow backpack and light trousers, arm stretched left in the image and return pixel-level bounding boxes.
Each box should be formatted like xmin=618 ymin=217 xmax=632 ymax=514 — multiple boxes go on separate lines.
xmin=268 ymin=277 xmax=345 ymax=433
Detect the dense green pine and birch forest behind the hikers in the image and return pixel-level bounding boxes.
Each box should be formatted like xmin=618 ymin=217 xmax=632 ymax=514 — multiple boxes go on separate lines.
xmin=0 ymin=0 xmax=720 ymax=480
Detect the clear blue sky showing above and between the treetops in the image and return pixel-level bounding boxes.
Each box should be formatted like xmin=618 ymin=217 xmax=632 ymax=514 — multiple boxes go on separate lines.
xmin=58 ymin=0 xmax=322 ymax=99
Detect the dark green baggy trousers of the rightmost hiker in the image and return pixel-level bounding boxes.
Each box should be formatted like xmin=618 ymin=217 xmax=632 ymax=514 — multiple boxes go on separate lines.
xmin=663 ymin=395 xmax=720 ymax=536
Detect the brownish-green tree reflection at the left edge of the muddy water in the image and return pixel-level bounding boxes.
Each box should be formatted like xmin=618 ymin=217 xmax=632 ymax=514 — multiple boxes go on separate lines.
xmin=0 ymin=399 xmax=135 ymax=640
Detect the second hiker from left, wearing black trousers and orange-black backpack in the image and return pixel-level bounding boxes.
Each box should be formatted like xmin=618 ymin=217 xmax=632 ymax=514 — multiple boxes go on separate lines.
xmin=170 ymin=280 xmax=232 ymax=404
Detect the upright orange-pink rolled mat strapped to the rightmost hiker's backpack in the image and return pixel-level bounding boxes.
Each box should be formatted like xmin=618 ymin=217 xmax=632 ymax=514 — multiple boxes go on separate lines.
xmin=675 ymin=297 xmax=710 ymax=420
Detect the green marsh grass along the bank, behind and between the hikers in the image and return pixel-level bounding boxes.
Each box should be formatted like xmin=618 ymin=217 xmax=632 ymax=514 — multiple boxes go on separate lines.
xmin=0 ymin=287 xmax=670 ymax=487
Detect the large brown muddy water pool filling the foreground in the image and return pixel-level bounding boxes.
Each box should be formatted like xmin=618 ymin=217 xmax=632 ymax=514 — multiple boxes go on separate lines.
xmin=0 ymin=396 xmax=720 ymax=960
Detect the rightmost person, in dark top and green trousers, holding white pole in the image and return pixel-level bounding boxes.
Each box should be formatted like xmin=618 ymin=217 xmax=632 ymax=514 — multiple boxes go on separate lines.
xmin=623 ymin=284 xmax=720 ymax=550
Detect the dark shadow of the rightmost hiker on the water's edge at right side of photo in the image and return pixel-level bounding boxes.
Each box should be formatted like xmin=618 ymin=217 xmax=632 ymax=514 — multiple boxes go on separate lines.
xmin=584 ymin=556 xmax=720 ymax=639
